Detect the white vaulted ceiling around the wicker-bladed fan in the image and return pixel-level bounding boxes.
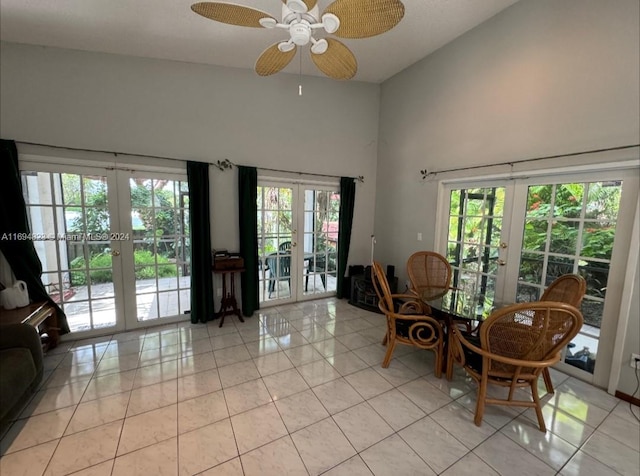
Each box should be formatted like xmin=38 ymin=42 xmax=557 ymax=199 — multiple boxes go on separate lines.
xmin=0 ymin=0 xmax=517 ymax=83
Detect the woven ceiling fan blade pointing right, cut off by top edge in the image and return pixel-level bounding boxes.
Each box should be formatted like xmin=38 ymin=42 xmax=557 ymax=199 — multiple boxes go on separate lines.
xmin=324 ymin=0 xmax=404 ymax=38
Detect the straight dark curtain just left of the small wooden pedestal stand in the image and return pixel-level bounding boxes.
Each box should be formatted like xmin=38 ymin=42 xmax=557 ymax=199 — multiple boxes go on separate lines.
xmin=187 ymin=162 xmax=215 ymax=324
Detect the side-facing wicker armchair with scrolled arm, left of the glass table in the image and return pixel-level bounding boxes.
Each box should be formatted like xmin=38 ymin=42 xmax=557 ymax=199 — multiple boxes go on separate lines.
xmin=371 ymin=261 xmax=444 ymax=378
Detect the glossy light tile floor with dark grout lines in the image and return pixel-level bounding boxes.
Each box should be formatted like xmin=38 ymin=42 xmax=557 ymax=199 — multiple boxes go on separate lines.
xmin=0 ymin=299 xmax=640 ymax=476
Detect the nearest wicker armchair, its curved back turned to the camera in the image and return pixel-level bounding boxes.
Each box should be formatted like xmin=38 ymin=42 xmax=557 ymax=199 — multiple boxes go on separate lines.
xmin=449 ymin=301 xmax=582 ymax=432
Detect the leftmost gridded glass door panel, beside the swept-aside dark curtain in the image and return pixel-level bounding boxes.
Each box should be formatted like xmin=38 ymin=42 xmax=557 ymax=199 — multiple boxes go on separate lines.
xmin=21 ymin=170 xmax=118 ymax=332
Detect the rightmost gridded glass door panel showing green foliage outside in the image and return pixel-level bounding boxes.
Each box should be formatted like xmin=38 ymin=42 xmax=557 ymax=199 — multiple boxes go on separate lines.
xmin=517 ymin=180 xmax=622 ymax=374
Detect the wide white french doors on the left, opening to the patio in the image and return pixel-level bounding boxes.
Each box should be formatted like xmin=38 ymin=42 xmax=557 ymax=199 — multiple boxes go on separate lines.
xmin=21 ymin=162 xmax=190 ymax=337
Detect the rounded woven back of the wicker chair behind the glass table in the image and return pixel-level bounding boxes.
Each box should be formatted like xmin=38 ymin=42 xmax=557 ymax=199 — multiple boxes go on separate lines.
xmin=407 ymin=251 xmax=451 ymax=301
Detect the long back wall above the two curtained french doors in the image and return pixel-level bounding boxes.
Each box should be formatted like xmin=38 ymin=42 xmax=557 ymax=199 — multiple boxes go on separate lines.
xmin=0 ymin=43 xmax=379 ymax=263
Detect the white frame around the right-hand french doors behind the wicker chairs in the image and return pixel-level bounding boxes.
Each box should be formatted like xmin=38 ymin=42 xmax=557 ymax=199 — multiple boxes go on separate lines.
xmin=434 ymin=160 xmax=640 ymax=388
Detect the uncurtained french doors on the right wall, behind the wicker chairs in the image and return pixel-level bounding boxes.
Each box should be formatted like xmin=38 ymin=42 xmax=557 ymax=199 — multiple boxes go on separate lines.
xmin=438 ymin=172 xmax=638 ymax=386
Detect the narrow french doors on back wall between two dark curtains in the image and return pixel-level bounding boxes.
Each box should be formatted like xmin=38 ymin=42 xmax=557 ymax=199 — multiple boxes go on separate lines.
xmin=257 ymin=180 xmax=340 ymax=304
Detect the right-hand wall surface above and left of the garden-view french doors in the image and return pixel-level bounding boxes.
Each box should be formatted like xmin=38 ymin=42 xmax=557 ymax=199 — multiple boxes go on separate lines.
xmin=375 ymin=0 xmax=640 ymax=390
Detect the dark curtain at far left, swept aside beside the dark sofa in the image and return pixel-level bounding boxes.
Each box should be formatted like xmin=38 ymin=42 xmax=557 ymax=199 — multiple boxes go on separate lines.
xmin=0 ymin=140 xmax=69 ymax=334
